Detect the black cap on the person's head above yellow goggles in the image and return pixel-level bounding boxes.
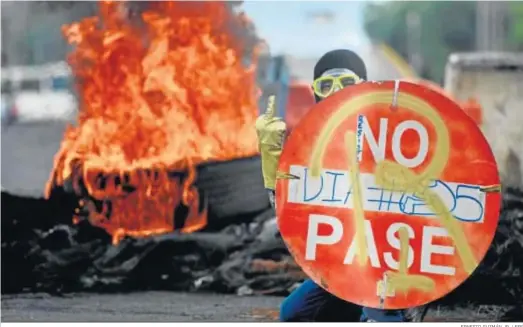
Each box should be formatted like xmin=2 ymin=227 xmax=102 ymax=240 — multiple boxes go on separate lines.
xmin=314 ymin=49 xmax=367 ymax=102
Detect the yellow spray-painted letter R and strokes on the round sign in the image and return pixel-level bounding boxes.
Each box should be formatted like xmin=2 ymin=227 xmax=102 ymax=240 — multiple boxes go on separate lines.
xmin=310 ymin=91 xmax=478 ymax=291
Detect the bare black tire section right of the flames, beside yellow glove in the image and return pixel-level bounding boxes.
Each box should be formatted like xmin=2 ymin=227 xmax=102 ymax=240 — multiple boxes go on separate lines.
xmin=196 ymin=156 xmax=270 ymax=224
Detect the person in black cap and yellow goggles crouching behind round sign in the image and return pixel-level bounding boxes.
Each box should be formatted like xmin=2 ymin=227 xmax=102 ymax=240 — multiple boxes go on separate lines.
xmin=256 ymin=49 xmax=421 ymax=322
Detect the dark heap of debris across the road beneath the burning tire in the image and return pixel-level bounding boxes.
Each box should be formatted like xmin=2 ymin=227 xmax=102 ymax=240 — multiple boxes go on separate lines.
xmin=2 ymin=189 xmax=523 ymax=319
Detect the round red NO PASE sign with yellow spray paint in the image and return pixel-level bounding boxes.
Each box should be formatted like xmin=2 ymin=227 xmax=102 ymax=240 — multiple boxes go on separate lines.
xmin=276 ymin=81 xmax=501 ymax=309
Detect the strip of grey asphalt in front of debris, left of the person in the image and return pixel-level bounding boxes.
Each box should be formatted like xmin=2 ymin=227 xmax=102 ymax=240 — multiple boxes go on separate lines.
xmin=2 ymin=292 xmax=282 ymax=322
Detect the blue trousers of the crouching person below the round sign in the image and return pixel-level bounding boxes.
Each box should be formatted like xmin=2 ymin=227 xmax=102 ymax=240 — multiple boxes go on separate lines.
xmin=280 ymin=279 xmax=405 ymax=322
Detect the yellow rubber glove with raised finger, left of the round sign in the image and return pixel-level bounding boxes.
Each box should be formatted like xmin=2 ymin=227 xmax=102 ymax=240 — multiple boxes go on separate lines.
xmin=256 ymin=95 xmax=287 ymax=190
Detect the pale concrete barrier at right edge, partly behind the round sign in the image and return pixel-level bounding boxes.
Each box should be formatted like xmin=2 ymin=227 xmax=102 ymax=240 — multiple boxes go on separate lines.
xmin=445 ymin=52 xmax=523 ymax=187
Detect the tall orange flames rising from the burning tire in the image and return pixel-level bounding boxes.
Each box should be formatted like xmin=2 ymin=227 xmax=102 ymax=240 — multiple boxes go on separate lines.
xmin=46 ymin=1 xmax=258 ymax=243
